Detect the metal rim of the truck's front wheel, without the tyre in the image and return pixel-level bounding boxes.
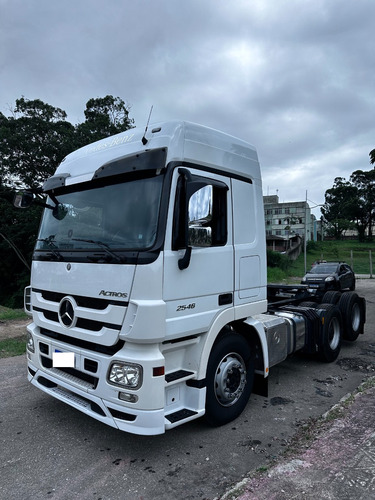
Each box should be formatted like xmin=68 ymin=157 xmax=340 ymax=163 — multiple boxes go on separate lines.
xmin=214 ymin=352 xmax=246 ymax=406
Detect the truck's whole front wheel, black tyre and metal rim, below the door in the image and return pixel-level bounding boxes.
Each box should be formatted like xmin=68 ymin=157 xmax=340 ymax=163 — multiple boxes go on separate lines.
xmin=205 ymin=333 xmax=254 ymax=426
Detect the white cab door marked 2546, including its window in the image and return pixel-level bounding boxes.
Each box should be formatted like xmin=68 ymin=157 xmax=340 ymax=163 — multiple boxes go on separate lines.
xmin=163 ymin=167 xmax=234 ymax=337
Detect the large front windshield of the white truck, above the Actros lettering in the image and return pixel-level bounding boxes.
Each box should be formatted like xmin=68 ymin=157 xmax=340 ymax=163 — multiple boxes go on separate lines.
xmin=36 ymin=175 xmax=163 ymax=254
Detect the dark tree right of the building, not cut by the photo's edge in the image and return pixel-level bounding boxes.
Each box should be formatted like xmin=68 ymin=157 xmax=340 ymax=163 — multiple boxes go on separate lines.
xmin=321 ymin=177 xmax=358 ymax=239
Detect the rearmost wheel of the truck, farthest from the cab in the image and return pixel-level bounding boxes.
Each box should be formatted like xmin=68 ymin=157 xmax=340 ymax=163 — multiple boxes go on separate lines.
xmin=338 ymin=292 xmax=365 ymax=342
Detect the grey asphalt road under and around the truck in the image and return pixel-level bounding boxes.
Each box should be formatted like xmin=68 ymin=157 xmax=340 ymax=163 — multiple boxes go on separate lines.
xmin=0 ymin=280 xmax=375 ymax=500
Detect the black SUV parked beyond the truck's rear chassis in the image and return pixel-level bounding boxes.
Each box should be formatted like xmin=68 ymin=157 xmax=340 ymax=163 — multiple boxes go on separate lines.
xmin=301 ymin=262 xmax=355 ymax=290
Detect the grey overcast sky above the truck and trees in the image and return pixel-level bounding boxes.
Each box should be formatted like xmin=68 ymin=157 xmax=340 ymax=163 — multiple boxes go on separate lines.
xmin=0 ymin=0 xmax=375 ymax=216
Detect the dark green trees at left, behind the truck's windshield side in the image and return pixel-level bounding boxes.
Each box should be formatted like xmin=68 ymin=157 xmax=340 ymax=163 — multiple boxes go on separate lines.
xmin=0 ymin=95 xmax=134 ymax=307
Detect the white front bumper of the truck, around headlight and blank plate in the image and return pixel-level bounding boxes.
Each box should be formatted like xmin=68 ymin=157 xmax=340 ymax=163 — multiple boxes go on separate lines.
xmin=27 ymin=323 xmax=206 ymax=435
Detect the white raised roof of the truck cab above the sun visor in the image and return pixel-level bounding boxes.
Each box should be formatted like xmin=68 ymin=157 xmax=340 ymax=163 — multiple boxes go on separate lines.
xmin=44 ymin=121 xmax=261 ymax=191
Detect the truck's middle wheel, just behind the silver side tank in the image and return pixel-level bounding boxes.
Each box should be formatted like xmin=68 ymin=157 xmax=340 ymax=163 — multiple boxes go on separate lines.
xmin=318 ymin=304 xmax=342 ymax=363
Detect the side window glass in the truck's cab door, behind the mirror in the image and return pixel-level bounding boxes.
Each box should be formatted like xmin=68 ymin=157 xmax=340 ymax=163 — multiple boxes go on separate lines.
xmin=188 ymin=184 xmax=227 ymax=247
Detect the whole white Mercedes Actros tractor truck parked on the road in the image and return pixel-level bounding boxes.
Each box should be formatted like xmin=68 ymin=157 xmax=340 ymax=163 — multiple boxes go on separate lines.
xmin=15 ymin=121 xmax=365 ymax=435
